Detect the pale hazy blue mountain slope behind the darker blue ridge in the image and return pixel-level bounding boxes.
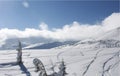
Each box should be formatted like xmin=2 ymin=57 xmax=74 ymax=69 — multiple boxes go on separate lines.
xmin=0 ymin=37 xmax=54 ymax=50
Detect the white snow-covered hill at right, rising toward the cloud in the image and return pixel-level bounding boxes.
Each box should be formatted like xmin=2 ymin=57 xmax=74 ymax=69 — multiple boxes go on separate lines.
xmin=78 ymin=27 xmax=120 ymax=48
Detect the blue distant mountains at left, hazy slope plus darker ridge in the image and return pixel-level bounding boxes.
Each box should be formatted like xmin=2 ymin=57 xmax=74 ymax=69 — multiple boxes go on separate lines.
xmin=0 ymin=37 xmax=77 ymax=50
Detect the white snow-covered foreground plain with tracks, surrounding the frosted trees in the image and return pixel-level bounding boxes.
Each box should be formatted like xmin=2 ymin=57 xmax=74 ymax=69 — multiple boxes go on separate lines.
xmin=0 ymin=43 xmax=120 ymax=76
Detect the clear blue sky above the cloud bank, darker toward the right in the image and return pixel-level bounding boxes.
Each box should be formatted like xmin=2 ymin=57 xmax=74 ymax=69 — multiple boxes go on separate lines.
xmin=0 ymin=0 xmax=120 ymax=30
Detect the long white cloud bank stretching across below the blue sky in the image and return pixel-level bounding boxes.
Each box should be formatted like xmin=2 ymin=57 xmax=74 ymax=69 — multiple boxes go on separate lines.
xmin=0 ymin=13 xmax=120 ymax=44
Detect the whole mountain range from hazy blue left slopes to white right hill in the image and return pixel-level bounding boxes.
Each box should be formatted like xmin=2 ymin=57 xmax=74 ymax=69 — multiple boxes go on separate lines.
xmin=0 ymin=27 xmax=120 ymax=50
